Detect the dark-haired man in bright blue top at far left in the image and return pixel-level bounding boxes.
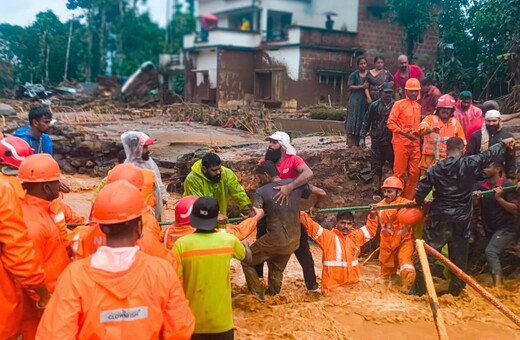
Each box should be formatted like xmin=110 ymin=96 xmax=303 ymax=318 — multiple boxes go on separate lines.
xmin=14 ymin=106 xmax=53 ymax=155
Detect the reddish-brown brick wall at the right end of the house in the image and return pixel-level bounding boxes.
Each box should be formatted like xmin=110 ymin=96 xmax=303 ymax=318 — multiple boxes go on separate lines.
xmin=357 ymin=0 xmax=439 ymax=74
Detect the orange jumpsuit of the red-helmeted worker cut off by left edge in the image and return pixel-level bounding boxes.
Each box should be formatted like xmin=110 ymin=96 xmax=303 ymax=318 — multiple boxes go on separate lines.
xmin=0 ymin=182 xmax=45 ymax=339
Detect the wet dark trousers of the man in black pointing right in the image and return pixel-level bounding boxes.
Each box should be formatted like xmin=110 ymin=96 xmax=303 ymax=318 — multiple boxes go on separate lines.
xmin=410 ymin=216 xmax=470 ymax=296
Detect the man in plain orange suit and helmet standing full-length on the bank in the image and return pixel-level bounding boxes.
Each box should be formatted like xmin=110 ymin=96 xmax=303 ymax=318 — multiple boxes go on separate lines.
xmin=387 ymin=78 xmax=421 ymax=199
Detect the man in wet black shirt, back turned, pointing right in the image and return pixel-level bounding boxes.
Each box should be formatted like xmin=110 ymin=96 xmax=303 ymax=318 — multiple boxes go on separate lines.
xmin=409 ymin=137 xmax=515 ymax=296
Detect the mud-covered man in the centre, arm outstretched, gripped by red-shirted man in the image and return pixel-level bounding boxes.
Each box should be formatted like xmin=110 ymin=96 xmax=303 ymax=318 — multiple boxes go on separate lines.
xmin=242 ymin=160 xmax=326 ymax=299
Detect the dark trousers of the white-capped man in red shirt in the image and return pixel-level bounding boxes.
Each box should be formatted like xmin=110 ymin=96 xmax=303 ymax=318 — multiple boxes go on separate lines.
xmin=255 ymin=222 xmax=318 ymax=289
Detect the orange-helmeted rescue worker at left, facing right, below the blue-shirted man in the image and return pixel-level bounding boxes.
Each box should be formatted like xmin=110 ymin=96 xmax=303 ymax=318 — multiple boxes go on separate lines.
xmin=18 ymin=153 xmax=70 ymax=339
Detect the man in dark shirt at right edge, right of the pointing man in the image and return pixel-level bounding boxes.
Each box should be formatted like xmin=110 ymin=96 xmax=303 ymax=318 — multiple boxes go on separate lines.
xmin=473 ymin=162 xmax=520 ymax=287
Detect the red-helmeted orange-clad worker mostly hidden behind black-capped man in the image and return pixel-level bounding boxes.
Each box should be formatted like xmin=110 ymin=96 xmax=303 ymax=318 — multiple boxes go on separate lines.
xmin=161 ymin=196 xmax=264 ymax=250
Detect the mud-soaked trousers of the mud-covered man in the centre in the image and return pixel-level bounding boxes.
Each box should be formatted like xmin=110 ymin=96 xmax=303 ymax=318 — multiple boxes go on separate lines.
xmin=242 ymin=252 xmax=291 ymax=296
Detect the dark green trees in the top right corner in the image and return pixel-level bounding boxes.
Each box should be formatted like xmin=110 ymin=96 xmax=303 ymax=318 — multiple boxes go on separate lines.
xmin=433 ymin=0 xmax=520 ymax=99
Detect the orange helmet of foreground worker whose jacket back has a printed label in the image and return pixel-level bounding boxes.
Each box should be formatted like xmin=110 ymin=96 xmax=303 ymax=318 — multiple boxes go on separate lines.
xmin=92 ymin=180 xmax=148 ymax=225
